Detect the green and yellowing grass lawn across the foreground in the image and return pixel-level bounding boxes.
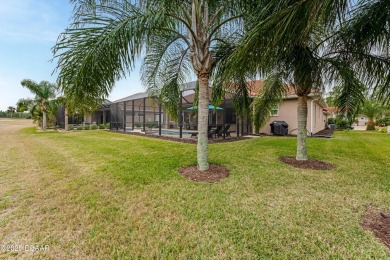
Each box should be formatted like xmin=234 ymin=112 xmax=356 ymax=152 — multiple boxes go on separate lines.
xmin=0 ymin=124 xmax=390 ymax=259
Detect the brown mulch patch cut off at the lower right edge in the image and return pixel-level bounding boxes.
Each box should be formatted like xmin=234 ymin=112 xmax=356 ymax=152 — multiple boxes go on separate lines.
xmin=362 ymin=207 xmax=390 ymax=249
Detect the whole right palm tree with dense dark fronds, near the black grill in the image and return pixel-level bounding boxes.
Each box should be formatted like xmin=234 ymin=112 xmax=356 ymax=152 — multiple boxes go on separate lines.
xmin=216 ymin=0 xmax=389 ymax=160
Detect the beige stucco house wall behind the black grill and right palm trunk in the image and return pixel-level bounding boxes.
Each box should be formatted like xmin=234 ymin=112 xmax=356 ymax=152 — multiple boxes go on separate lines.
xmin=260 ymin=98 xmax=327 ymax=135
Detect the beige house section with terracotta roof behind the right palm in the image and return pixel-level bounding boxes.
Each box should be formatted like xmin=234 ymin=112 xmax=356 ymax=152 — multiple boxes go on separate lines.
xmin=250 ymin=80 xmax=329 ymax=135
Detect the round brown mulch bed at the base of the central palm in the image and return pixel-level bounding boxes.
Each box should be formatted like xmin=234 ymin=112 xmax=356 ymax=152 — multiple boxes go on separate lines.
xmin=179 ymin=164 xmax=229 ymax=183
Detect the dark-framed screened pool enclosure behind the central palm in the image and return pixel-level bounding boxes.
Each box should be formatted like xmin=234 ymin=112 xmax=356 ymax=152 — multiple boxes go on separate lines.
xmin=110 ymin=82 xmax=252 ymax=138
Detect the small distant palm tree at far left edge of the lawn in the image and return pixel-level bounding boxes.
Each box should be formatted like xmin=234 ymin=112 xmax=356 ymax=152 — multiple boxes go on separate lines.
xmin=18 ymin=79 xmax=56 ymax=131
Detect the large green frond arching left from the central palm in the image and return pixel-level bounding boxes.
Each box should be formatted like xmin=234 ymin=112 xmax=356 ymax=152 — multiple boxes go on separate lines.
xmin=53 ymin=1 xmax=147 ymax=104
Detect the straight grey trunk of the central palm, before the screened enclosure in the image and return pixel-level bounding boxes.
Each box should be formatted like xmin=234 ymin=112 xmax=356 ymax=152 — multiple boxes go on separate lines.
xmin=197 ymin=75 xmax=209 ymax=171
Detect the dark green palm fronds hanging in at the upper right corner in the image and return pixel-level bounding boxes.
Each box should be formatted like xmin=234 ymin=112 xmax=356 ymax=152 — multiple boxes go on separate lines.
xmin=336 ymin=0 xmax=390 ymax=112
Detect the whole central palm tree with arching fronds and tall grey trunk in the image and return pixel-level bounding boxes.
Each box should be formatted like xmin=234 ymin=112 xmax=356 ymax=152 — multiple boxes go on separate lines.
xmin=53 ymin=0 xmax=253 ymax=171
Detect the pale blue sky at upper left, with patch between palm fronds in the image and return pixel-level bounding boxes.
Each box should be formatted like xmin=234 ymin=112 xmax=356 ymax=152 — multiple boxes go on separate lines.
xmin=0 ymin=0 xmax=144 ymax=110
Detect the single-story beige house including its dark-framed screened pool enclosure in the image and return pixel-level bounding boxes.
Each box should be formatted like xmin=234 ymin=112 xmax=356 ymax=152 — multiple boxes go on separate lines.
xmin=110 ymin=80 xmax=328 ymax=137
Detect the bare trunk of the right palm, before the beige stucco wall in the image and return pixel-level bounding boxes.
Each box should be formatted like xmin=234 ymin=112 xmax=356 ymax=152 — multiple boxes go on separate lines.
xmin=296 ymin=96 xmax=307 ymax=161
